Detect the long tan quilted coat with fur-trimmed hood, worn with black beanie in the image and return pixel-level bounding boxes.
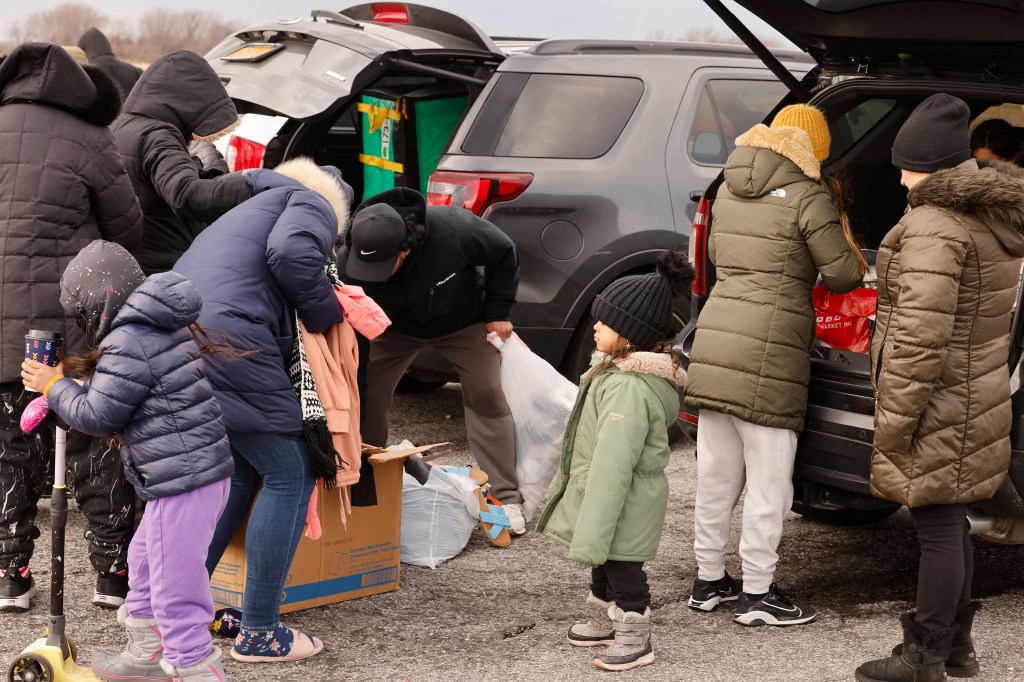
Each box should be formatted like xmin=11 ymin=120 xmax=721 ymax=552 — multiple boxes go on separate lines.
xmin=871 ymin=159 xmax=1024 ymax=507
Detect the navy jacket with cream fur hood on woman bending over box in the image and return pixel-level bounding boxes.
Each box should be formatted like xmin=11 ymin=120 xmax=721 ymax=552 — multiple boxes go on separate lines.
xmin=174 ymin=159 xmax=348 ymax=430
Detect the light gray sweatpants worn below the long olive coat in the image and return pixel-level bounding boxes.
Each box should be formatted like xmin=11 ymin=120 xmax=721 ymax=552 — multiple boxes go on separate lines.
xmin=693 ymin=410 xmax=797 ymax=594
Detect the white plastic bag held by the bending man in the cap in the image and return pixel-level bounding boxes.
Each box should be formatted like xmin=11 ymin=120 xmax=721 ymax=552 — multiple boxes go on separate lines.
xmin=490 ymin=334 xmax=579 ymax=520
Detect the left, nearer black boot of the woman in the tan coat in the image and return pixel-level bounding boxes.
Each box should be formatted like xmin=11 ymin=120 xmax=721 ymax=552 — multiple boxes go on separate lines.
xmin=857 ymin=613 xmax=955 ymax=682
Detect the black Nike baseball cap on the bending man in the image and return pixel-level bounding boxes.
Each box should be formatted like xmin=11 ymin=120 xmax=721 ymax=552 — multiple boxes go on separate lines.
xmin=345 ymin=204 xmax=406 ymax=282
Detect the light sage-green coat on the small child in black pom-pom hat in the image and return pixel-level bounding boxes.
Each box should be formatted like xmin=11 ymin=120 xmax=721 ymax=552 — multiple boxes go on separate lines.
xmin=537 ymin=352 xmax=686 ymax=566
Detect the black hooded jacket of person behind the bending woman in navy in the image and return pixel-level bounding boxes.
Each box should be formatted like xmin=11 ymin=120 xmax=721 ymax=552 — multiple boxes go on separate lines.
xmin=112 ymin=51 xmax=249 ymax=274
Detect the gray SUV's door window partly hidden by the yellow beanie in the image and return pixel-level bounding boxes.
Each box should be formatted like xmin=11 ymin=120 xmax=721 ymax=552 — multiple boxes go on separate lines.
xmin=686 ymin=79 xmax=785 ymax=166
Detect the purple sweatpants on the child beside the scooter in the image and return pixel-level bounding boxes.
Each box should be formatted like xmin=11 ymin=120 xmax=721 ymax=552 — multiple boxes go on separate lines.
xmin=125 ymin=478 xmax=231 ymax=668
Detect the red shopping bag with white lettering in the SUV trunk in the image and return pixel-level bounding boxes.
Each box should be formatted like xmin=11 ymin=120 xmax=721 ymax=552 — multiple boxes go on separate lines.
xmin=811 ymin=285 xmax=879 ymax=353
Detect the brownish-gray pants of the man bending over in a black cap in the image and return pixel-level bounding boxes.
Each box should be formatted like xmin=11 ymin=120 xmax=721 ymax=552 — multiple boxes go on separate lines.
xmin=360 ymin=324 xmax=522 ymax=504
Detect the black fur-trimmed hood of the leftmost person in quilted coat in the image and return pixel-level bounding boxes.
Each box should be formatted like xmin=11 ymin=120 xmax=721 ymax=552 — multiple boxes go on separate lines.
xmin=0 ymin=43 xmax=121 ymax=127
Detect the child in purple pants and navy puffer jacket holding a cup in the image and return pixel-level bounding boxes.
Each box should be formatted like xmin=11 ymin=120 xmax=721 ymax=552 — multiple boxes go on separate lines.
xmin=22 ymin=240 xmax=234 ymax=682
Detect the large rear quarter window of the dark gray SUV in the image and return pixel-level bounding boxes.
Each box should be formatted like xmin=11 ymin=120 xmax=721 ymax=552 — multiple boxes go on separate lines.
xmin=462 ymin=73 xmax=643 ymax=159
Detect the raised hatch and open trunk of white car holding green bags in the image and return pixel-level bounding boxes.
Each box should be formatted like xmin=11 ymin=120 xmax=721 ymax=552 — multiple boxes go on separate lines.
xmin=206 ymin=3 xmax=505 ymax=201
